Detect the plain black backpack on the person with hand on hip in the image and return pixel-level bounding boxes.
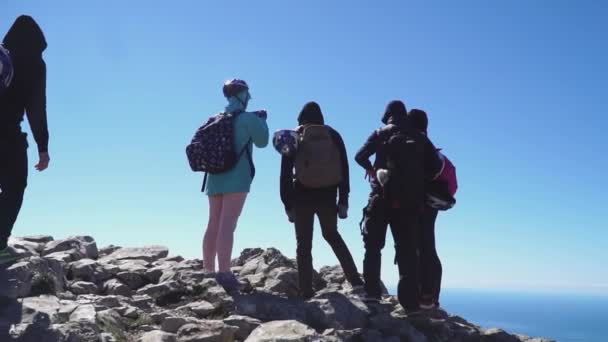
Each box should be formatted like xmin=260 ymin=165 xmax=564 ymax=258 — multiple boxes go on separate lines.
xmin=384 ymin=128 xmax=425 ymax=210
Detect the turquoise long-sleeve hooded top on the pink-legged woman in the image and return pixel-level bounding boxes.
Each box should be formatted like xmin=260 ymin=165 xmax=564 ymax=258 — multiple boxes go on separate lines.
xmin=207 ymin=98 xmax=269 ymax=196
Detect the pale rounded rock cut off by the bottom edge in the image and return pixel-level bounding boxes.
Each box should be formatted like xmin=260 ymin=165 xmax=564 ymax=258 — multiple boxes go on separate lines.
xmin=245 ymin=320 xmax=321 ymax=342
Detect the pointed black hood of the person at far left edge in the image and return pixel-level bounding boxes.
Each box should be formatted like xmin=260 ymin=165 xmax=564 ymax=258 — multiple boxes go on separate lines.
xmin=3 ymin=15 xmax=47 ymax=56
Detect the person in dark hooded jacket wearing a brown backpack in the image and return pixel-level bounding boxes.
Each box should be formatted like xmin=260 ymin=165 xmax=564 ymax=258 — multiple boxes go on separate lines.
xmin=281 ymin=102 xmax=363 ymax=299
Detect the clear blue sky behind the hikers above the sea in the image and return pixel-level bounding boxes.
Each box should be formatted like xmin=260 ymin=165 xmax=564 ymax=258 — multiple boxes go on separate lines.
xmin=0 ymin=0 xmax=608 ymax=294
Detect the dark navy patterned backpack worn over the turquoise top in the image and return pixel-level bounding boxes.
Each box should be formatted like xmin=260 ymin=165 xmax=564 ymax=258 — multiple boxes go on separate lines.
xmin=186 ymin=113 xmax=249 ymax=174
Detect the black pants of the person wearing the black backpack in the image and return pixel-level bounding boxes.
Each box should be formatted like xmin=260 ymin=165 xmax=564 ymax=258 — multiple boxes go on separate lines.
xmin=361 ymin=194 xmax=419 ymax=309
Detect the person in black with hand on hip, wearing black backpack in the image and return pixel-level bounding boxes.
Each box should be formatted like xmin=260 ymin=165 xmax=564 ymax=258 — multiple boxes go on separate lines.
xmin=355 ymin=101 xmax=440 ymax=312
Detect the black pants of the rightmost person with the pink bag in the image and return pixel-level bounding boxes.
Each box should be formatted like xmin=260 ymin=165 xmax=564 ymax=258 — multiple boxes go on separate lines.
xmin=420 ymin=206 xmax=443 ymax=302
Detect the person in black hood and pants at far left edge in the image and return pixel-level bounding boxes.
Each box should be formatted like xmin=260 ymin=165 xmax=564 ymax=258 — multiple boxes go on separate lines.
xmin=0 ymin=15 xmax=50 ymax=264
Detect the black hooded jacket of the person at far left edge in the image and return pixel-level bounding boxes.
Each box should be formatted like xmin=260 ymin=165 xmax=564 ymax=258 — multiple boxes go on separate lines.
xmin=0 ymin=15 xmax=49 ymax=152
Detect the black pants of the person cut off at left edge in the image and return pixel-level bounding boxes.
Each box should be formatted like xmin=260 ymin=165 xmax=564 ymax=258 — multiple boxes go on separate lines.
xmin=0 ymin=134 xmax=27 ymax=249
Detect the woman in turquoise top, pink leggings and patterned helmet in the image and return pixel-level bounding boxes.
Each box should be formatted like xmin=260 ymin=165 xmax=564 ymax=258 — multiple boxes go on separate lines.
xmin=203 ymin=79 xmax=268 ymax=290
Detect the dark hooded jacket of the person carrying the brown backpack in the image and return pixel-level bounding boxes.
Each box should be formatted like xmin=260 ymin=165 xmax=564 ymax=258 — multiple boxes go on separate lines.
xmin=281 ymin=102 xmax=350 ymax=210
